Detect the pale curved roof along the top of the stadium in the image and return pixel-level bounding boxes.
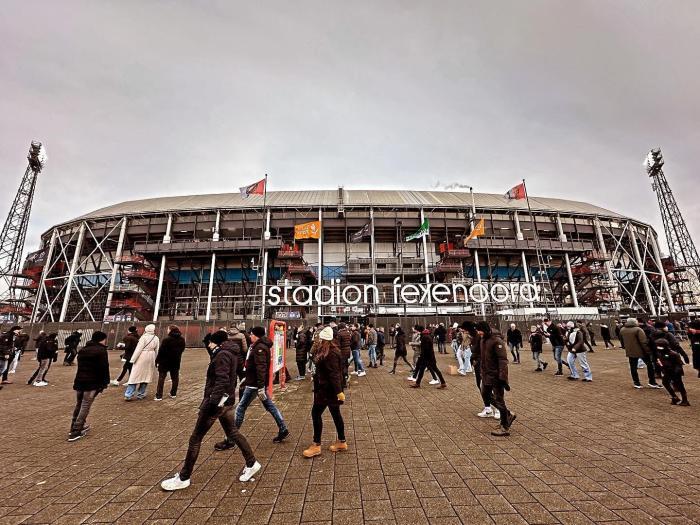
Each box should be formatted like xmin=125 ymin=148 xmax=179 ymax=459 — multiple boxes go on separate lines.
xmin=74 ymin=190 xmax=623 ymax=222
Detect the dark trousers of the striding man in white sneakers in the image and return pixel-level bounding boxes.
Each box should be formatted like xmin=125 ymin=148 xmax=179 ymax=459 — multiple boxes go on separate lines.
xmin=180 ymin=406 xmax=255 ymax=481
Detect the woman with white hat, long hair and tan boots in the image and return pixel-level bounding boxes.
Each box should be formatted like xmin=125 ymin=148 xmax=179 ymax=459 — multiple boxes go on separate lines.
xmin=303 ymin=325 xmax=346 ymax=458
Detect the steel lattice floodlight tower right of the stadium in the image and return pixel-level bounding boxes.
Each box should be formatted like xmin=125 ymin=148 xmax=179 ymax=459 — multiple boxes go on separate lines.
xmin=644 ymin=148 xmax=700 ymax=304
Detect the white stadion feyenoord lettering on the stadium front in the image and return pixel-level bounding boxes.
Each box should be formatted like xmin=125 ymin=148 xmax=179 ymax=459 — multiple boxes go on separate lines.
xmin=265 ymin=277 xmax=540 ymax=306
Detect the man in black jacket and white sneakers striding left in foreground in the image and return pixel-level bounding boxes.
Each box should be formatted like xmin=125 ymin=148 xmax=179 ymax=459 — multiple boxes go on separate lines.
xmin=160 ymin=330 xmax=262 ymax=491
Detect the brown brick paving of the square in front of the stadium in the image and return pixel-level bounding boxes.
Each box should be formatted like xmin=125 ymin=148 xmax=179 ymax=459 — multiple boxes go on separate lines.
xmin=0 ymin=342 xmax=700 ymax=525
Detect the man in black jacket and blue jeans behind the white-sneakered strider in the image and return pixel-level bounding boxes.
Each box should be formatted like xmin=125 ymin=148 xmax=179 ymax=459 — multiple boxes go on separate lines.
xmin=236 ymin=326 xmax=289 ymax=443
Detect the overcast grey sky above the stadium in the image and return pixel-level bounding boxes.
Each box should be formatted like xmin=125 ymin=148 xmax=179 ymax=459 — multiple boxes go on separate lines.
xmin=0 ymin=0 xmax=700 ymax=254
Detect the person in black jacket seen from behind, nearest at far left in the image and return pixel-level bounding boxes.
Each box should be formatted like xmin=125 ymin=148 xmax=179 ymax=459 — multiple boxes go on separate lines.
xmin=68 ymin=330 xmax=109 ymax=441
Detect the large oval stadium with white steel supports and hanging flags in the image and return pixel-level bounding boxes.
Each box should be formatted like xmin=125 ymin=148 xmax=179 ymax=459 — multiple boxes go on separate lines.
xmin=21 ymin=188 xmax=684 ymax=323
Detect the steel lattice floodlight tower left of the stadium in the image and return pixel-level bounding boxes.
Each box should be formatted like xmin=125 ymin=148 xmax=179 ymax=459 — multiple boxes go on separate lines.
xmin=0 ymin=141 xmax=46 ymax=314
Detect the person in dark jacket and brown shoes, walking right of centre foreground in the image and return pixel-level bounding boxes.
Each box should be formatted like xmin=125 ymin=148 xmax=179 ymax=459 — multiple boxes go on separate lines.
xmin=475 ymin=321 xmax=517 ymax=437
